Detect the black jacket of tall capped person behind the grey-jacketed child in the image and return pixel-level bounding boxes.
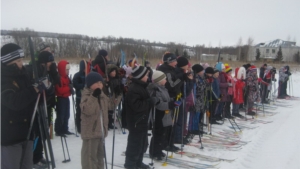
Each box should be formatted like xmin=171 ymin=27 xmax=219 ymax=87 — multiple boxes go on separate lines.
xmin=157 ymin=63 xmax=183 ymax=100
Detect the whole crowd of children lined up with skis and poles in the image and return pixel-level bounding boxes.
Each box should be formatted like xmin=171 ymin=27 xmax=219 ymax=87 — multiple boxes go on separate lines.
xmin=1 ymin=43 xmax=291 ymax=169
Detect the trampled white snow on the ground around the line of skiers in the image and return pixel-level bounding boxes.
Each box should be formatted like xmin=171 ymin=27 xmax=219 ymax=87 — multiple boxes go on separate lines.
xmin=52 ymin=65 xmax=300 ymax=169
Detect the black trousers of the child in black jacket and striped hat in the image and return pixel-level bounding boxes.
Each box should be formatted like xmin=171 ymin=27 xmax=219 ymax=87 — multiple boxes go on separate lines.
xmin=124 ymin=129 xmax=148 ymax=168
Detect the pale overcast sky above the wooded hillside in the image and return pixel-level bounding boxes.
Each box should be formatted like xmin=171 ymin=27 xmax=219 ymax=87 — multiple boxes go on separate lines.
xmin=1 ymin=0 xmax=300 ymax=46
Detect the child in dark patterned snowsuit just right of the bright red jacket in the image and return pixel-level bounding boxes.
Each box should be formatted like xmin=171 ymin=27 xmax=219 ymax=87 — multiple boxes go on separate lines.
xmin=246 ymin=65 xmax=260 ymax=116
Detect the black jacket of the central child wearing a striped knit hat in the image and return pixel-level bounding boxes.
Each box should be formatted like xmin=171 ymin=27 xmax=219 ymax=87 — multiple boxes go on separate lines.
xmin=125 ymin=79 xmax=151 ymax=131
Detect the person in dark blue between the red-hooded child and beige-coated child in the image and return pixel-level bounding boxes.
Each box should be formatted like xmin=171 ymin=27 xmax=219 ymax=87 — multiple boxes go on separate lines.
xmin=72 ymin=60 xmax=86 ymax=133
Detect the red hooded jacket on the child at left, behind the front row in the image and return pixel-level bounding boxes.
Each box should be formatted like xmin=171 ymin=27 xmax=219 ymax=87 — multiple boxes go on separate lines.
xmin=55 ymin=60 xmax=71 ymax=97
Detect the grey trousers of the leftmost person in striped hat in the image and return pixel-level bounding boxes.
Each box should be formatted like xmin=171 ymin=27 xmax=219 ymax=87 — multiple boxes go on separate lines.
xmin=1 ymin=141 xmax=33 ymax=169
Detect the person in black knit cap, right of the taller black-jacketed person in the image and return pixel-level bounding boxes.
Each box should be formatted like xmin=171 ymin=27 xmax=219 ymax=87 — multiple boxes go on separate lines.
xmin=174 ymin=56 xmax=193 ymax=144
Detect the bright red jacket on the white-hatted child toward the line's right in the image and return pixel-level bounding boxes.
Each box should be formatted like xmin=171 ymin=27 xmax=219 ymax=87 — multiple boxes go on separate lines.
xmin=232 ymin=68 xmax=245 ymax=104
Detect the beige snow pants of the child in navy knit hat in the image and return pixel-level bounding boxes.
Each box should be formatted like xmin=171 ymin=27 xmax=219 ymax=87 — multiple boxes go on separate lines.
xmin=81 ymin=138 xmax=105 ymax=169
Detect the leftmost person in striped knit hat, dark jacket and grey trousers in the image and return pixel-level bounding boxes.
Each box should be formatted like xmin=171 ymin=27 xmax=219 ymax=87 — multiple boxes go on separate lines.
xmin=1 ymin=43 xmax=46 ymax=169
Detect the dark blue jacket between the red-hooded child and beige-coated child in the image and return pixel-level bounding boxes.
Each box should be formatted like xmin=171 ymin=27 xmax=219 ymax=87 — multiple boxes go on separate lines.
xmin=73 ymin=60 xmax=85 ymax=100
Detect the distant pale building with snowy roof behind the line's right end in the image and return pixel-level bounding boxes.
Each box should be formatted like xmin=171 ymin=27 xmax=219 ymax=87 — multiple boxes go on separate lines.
xmin=249 ymin=39 xmax=300 ymax=62
